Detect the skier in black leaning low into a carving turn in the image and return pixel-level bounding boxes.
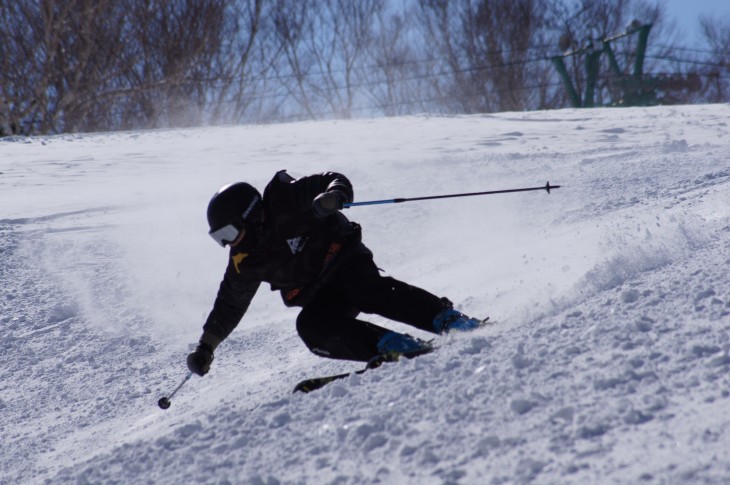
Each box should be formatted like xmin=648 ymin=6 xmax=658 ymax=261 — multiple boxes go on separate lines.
xmin=187 ymin=170 xmax=481 ymax=376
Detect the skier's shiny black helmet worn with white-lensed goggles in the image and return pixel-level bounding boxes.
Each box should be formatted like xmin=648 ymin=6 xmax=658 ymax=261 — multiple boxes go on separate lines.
xmin=208 ymin=182 xmax=262 ymax=246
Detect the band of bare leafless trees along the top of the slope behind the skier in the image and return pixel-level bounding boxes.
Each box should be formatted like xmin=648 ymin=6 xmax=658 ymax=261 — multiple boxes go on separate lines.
xmin=0 ymin=0 xmax=730 ymax=136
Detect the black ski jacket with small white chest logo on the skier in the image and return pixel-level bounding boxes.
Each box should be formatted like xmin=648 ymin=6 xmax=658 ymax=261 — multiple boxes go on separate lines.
xmin=202 ymin=170 xmax=368 ymax=348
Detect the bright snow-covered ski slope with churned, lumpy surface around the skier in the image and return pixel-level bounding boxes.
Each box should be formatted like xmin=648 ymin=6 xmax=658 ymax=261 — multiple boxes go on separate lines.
xmin=0 ymin=105 xmax=730 ymax=484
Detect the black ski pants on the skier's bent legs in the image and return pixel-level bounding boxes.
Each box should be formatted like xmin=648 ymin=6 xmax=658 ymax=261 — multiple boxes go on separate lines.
xmin=297 ymin=251 xmax=445 ymax=362
